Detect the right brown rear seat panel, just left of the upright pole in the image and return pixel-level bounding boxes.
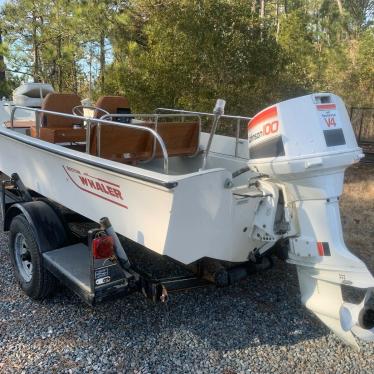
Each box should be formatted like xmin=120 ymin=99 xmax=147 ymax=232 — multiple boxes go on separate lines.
xmin=156 ymin=122 xmax=200 ymax=158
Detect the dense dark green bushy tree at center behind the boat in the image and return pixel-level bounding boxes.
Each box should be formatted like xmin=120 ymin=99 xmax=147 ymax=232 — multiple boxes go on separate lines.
xmin=109 ymin=0 xmax=282 ymax=111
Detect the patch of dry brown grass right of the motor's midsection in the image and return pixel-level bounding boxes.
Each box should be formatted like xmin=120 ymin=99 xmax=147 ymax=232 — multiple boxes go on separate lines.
xmin=341 ymin=164 xmax=374 ymax=273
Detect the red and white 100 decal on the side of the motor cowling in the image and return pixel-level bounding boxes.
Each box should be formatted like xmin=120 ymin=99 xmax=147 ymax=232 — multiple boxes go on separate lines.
xmin=248 ymin=106 xmax=279 ymax=143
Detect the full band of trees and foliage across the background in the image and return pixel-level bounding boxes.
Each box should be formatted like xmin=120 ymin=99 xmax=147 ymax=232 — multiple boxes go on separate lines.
xmin=0 ymin=0 xmax=374 ymax=114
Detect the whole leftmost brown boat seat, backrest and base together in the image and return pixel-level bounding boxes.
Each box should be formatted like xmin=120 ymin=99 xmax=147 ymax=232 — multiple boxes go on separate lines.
xmin=31 ymin=92 xmax=86 ymax=143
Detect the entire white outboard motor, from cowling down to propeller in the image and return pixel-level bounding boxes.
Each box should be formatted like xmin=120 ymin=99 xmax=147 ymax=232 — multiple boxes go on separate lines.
xmin=248 ymin=93 xmax=374 ymax=346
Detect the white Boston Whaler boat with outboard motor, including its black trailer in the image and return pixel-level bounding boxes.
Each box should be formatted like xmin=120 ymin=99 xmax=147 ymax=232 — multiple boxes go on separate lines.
xmin=0 ymin=85 xmax=374 ymax=346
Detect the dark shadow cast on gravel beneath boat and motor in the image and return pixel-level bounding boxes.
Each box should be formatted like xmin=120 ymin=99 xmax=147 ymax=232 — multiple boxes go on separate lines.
xmin=35 ymin=261 xmax=327 ymax=352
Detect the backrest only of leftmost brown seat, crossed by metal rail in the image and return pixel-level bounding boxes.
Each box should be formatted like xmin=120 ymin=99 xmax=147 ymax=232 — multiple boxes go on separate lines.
xmin=40 ymin=92 xmax=82 ymax=128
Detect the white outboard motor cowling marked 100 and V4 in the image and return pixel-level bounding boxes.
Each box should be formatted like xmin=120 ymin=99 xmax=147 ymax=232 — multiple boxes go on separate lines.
xmin=248 ymin=94 xmax=363 ymax=179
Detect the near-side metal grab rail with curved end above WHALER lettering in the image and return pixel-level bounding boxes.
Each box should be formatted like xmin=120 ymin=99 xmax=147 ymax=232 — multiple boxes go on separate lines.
xmin=10 ymin=105 xmax=169 ymax=174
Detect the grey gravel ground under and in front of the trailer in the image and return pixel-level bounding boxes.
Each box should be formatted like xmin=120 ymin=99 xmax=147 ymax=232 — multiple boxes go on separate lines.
xmin=0 ymin=172 xmax=374 ymax=374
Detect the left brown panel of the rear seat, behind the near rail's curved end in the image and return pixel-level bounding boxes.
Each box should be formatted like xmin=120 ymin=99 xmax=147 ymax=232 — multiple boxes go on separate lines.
xmin=90 ymin=124 xmax=153 ymax=163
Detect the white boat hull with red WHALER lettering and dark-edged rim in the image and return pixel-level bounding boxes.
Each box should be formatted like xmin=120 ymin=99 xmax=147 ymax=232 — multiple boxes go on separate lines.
xmin=0 ymin=128 xmax=258 ymax=264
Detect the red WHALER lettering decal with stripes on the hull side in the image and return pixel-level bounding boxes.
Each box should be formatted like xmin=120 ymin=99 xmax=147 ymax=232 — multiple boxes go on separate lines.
xmin=63 ymin=166 xmax=128 ymax=209
